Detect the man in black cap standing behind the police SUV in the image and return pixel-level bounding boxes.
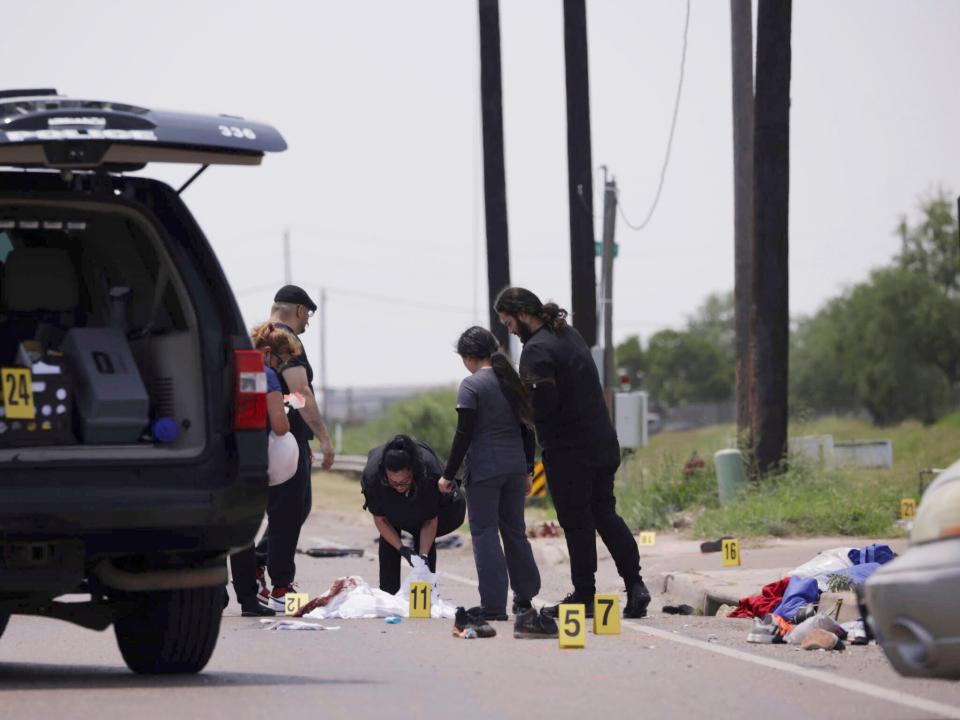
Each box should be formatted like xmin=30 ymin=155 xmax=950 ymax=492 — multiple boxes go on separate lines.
xmin=257 ymin=285 xmax=334 ymax=610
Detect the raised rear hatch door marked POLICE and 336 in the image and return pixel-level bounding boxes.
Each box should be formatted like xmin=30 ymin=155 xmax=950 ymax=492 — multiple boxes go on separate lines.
xmin=0 ymin=90 xmax=287 ymax=171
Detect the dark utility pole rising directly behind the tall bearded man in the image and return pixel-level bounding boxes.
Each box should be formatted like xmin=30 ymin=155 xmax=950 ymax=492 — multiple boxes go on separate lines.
xmin=563 ymin=0 xmax=597 ymax=346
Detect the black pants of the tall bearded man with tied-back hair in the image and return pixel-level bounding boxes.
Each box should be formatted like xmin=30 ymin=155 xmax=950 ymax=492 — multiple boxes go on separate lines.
xmin=543 ymin=449 xmax=640 ymax=597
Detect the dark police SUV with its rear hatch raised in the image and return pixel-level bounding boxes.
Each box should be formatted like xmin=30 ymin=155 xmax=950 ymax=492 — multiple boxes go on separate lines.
xmin=0 ymin=90 xmax=286 ymax=673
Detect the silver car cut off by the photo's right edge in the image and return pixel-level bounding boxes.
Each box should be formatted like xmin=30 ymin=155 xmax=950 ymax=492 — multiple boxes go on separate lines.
xmin=864 ymin=461 xmax=960 ymax=680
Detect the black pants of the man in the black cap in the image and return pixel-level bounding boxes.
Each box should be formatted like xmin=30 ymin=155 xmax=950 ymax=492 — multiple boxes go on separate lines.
xmin=254 ymin=443 xmax=313 ymax=587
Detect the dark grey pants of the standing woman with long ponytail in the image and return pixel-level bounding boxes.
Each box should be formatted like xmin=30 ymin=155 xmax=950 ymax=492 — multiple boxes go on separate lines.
xmin=467 ymin=473 xmax=540 ymax=613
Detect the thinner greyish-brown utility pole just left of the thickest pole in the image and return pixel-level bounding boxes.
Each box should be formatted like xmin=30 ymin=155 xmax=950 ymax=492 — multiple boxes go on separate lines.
xmin=730 ymin=0 xmax=754 ymax=450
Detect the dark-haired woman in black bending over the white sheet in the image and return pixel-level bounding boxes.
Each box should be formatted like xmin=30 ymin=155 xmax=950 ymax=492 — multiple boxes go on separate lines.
xmin=361 ymin=435 xmax=467 ymax=595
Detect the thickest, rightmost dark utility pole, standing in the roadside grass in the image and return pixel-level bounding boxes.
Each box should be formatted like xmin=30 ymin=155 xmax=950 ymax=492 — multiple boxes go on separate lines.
xmin=751 ymin=0 xmax=792 ymax=473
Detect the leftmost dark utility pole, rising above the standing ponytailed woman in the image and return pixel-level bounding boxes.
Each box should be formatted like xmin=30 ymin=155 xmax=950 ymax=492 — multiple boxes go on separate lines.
xmin=477 ymin=0 xmax=510 ymax=349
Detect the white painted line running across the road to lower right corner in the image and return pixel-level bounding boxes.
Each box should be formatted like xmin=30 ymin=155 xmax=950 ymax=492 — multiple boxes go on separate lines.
xmin=623 ymin=622 xmax=960 ymax=720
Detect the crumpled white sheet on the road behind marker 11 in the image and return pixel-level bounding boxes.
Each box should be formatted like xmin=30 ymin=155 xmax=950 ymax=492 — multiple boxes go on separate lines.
xmin=304 ymin=557 xmax=457 ymax=620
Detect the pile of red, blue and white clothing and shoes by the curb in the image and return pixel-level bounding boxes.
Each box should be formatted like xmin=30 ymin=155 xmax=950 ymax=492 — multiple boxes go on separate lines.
xmin=727 ymin=544 xmax=896 ymax=650
